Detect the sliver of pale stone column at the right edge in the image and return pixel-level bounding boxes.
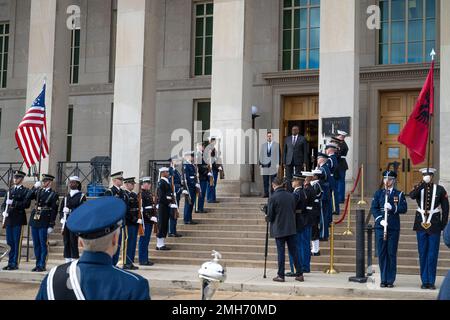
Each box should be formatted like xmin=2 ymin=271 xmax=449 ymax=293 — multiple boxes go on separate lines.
xmin=435 ymin=1 xmax=450 ymax=190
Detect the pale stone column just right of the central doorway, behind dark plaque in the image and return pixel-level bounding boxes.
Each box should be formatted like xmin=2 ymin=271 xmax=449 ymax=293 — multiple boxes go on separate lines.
xmin=319 ymin=0 xmax=360 ymax=189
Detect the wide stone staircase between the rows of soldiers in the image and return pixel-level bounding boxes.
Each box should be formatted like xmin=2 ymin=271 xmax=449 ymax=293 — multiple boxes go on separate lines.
xmin=0 ymin=197 xmax=450 ymax=275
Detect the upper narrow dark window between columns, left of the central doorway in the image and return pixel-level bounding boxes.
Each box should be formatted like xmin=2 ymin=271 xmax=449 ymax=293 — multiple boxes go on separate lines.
xmin=194 ymin=2 xmax=214 ymax=76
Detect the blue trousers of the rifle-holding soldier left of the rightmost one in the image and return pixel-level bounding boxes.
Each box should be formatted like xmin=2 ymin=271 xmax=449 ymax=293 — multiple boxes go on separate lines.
xmin=375 ymin=229 xmax=400 ymax=284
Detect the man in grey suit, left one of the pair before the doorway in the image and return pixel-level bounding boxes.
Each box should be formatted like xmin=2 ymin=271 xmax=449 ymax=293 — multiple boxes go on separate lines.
xmin=259 ymin=131 xmax=281 ymax=198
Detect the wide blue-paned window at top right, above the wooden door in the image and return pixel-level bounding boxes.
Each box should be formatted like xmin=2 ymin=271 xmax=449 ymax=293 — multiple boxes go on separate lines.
xmin=378 ymin=0 xmax=436 ymax=64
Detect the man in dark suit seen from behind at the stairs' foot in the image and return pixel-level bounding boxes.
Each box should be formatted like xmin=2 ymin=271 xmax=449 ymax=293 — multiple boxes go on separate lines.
xmin=267 ymin=177 xmax=304 ymax=282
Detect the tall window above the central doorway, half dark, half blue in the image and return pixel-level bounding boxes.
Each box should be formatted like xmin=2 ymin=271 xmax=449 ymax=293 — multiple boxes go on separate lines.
xmin=282 ymin=0 xmax=320 ymax=70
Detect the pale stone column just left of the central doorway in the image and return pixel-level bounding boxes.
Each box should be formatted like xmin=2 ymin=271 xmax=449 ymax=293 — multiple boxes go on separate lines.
xmin=211 ymin=0 xmax=256 ymax=196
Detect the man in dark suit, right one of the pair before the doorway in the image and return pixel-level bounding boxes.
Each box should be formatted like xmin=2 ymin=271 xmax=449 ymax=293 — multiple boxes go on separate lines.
xmin=283 ymin=126 xmax=309 ymax=188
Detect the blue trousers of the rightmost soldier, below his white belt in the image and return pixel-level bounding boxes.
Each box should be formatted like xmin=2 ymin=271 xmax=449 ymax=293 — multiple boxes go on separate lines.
xmin=417 ymin=231 xmax=441 ymax=285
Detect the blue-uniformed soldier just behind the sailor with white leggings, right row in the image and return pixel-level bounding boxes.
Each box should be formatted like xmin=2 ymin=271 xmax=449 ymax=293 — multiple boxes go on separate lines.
xmin=317 ymin=152 xmax=333 ymax=241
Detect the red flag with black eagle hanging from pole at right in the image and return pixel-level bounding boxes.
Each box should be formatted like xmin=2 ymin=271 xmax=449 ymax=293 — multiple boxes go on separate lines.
xmin=398 ymin=61 xmax=434 ymax=165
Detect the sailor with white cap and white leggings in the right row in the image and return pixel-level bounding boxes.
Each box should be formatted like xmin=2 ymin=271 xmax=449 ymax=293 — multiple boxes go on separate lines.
xmin=305 ymin=170 xmax=323 ymax=257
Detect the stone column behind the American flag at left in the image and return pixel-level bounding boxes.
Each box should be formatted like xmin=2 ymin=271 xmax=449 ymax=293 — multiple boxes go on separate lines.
xmin=26 ymin=0 xmax=70 ymax=175
